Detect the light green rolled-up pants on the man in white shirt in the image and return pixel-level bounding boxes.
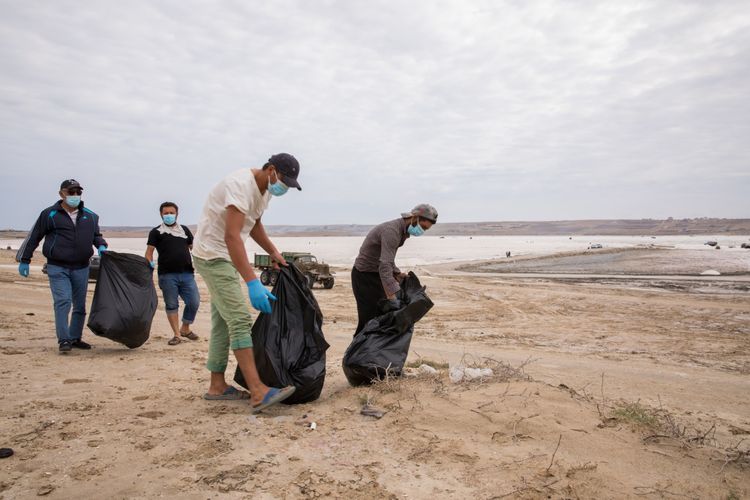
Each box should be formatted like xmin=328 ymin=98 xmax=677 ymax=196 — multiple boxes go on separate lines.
xmin=193 ymin=257 xmax=253 ymax=373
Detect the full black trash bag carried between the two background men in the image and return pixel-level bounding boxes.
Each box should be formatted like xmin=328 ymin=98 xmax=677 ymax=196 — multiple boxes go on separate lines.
xmin=88 ymin=254 xmax=157 ymax=349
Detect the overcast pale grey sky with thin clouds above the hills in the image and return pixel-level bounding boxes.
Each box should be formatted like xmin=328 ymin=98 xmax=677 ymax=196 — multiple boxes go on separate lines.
xmin=0 ymin=0 xmax=750 ymax=229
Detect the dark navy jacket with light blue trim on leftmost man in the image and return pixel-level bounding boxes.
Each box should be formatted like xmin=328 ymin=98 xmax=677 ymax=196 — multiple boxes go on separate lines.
xmin=20 ymin=200 xmax=107 ymax=269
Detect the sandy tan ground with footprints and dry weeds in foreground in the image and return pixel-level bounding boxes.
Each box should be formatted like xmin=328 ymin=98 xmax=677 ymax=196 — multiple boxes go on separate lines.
xmin=0 ymin=248 xmax=750 ymax=499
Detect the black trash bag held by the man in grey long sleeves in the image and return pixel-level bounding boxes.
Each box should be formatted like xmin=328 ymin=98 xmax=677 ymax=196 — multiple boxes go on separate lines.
xmin=342 ymin=272 xmax=433 ymax=386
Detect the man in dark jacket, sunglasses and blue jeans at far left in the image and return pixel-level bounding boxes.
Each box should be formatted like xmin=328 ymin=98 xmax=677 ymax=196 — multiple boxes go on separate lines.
xmin=18 ymin=179 xmax=107 ymax=354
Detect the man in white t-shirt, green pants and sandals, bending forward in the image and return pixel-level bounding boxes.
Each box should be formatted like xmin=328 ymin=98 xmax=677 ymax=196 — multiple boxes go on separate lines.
xmin=193 ymin=153 xmax=302 ymax=413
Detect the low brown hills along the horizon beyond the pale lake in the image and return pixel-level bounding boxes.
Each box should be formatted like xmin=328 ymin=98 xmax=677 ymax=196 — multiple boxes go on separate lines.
xmin=0 ymin=218 xmax=750 ymax=238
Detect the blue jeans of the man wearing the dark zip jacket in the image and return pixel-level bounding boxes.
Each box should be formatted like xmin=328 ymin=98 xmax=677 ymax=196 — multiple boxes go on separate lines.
xmin=47 ymin=264 xmax=89 ymax=344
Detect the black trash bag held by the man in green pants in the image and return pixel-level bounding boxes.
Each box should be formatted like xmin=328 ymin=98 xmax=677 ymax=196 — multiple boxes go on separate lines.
xmin=234 ymin=264 xmax=328 ymax=404
